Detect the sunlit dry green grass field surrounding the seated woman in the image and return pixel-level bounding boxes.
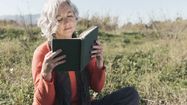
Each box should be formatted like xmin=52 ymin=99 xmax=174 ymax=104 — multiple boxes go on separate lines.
xmin=0 ymin=19 xmax=187 ymax=105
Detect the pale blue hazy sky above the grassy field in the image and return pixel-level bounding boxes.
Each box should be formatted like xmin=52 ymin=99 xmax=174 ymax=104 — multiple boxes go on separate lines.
xmin=0 ymin=0 xmax=187 ymax=23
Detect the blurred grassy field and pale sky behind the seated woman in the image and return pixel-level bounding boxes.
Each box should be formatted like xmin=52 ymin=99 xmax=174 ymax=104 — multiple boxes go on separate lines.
xmin=0 ymin=0 xmax=187 ymax=105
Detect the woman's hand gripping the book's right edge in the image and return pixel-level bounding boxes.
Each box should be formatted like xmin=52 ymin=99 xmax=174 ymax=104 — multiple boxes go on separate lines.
xmin=91 ymin=40 xmax=103 ymax=69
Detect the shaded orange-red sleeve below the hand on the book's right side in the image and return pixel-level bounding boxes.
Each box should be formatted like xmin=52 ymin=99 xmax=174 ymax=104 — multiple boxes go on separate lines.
xmin=87 ymin=58 xmax=106 ymax=92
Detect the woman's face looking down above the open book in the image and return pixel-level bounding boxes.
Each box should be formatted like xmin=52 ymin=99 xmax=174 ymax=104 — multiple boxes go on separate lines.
xmin=56 ymin=4 xmax=77 ymax=39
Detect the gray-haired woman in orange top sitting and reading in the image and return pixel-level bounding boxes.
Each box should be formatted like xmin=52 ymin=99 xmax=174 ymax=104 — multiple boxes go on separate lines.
xmin=32 ymin=0 xmax=139 ymax=105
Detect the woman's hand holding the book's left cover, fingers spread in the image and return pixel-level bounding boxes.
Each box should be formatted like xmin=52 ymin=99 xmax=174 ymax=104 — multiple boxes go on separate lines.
xmin=41 ymin=49 xmax=66 ymax=81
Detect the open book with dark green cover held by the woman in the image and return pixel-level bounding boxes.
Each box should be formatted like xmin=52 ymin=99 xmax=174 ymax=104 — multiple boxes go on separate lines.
xmin=52 ymin=26 xmax=98 ymax=71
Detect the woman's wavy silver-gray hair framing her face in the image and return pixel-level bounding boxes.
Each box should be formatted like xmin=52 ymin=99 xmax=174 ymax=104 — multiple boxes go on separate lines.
xmin=38 ymin=0 xmax=79 ymax=40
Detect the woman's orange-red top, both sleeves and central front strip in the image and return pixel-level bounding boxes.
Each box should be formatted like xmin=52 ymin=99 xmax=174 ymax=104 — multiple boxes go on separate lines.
xmin=32 ymin=42 xmax=105 ymax=105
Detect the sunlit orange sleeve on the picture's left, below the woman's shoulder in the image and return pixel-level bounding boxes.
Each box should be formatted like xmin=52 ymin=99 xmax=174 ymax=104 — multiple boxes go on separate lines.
xmin=32 ymin=50 xmax=55 ymax=105
